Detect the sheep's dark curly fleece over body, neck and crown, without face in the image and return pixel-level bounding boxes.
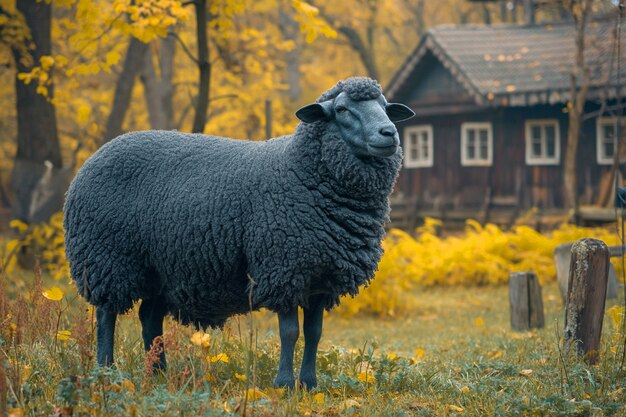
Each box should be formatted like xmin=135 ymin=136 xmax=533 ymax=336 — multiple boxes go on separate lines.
xmin=65 ymin=78 xmax=401 ymax=327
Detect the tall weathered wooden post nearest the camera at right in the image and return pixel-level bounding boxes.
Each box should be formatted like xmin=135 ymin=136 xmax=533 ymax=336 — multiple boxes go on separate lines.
xmin=564 ymin=239 xmax=609 ymax=364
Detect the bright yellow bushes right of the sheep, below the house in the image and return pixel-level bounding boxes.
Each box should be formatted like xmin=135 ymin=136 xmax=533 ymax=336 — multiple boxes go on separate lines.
xmin=340 ymin=219 xmax=620 ymax=316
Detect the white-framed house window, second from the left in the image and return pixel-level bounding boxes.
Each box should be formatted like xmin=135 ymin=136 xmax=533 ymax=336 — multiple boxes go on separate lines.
xmin=461 ymin=122 xmax=493 ymax=166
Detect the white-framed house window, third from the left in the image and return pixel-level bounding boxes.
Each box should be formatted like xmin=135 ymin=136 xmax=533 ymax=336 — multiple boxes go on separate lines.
xmin=526 ymin=119 xmax=561 ymax=165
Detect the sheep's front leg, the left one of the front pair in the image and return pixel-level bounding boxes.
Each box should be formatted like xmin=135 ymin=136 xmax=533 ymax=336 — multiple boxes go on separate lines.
xmin=274 ymin=307 xmax=300 ymax=388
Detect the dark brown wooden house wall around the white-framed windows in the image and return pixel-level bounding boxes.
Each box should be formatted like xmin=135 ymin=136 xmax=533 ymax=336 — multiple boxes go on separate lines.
xmin=397 ymin=101 xmax=610 ymax=210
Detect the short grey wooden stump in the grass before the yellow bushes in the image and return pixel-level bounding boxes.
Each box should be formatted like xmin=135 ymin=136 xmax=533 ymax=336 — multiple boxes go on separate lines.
xmin=509 ymin=272 xmax=544 ymax=331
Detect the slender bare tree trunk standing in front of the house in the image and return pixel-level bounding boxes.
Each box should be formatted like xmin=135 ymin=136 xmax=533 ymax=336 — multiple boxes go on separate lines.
xmin=563 ymin=0 xmax=592 ymax=223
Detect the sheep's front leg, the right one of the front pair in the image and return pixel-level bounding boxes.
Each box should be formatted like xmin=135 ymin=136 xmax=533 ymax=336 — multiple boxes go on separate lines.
xmin=300 ymin=295 xmax=324 ymax=389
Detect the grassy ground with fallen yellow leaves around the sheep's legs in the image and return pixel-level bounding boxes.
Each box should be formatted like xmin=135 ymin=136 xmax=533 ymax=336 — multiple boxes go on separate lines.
xmin=2 ymin=272 xmax=626 ymax=416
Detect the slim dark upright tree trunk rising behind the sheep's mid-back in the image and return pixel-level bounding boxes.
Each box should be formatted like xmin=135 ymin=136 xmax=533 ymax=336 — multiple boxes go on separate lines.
xmin=191 ymin=0 xmax=211 ymax=133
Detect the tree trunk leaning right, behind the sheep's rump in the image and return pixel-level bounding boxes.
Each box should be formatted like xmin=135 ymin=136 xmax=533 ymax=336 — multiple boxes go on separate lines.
xmin=102 ymin=36 xmax=148 ymax=143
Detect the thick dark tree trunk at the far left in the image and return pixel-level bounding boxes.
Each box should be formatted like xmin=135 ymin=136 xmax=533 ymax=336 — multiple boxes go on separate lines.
xmin=11 ymin=0 xmax=67 ymax=222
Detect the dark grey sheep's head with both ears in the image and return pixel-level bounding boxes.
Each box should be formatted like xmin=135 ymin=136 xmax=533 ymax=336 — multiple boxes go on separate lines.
xmin=296 ymin=78 xmax=415 ymax=157
